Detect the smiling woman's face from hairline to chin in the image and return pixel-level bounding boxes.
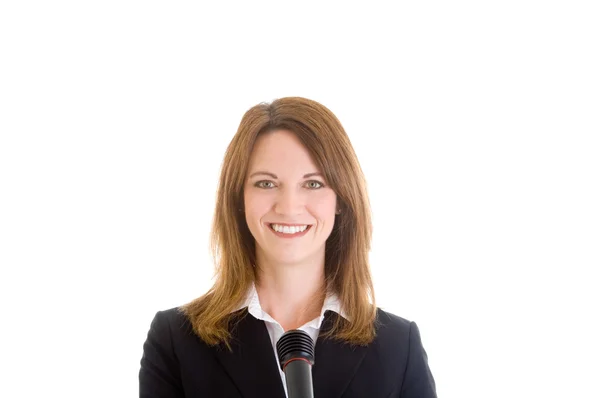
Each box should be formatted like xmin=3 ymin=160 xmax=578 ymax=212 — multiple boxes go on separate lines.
xmin=244 ymin=130 xmax=336 ymax=264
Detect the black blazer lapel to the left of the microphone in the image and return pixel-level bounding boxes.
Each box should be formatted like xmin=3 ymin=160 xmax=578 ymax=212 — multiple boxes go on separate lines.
xmin=215 ymin=309 xmax=285 ymax=398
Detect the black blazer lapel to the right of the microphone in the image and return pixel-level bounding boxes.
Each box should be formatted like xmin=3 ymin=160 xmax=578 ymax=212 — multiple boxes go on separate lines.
xmin=312 ymin=311 xmax=367 ymax=398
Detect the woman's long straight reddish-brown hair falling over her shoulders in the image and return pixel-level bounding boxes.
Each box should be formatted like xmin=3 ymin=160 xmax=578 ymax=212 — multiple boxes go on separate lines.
xmin=180 ymin=97 xmax=377 ymax=347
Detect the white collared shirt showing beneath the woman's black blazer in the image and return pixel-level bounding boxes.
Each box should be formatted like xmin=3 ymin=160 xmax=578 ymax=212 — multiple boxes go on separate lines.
xmin=239 ymin=284 xmax=347 ymax=396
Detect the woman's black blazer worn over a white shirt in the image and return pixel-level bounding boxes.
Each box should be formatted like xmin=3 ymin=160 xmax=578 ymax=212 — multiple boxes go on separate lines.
xmin=139 ymin=308 xmax=436 ymax=398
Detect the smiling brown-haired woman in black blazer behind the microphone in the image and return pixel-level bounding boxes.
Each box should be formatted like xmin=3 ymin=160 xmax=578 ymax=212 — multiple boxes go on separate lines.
xmin=139 ymin=97 xmax=436 ymax=398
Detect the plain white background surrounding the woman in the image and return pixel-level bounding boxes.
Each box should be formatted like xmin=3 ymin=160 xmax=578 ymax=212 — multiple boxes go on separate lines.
xmin=0 ymin=0 xmax=600 ymax=398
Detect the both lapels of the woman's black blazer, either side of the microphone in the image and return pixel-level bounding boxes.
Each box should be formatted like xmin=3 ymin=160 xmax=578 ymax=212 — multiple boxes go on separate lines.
xmin=215 ymin=309 xmax=366 ymax=398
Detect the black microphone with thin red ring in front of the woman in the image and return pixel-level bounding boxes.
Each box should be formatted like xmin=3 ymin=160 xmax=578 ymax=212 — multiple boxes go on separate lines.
xmin=276 ymin=329 xmax=315 ymax=398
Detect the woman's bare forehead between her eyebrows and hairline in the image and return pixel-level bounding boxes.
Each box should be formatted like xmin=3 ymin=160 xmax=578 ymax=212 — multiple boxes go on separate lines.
xmin=249 ymin=130 xmax=318 ymax=173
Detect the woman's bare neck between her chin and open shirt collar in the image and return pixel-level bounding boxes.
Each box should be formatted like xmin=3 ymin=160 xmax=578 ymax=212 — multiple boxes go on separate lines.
xmin=256 ymin=256 xmax=325 ymax=331
